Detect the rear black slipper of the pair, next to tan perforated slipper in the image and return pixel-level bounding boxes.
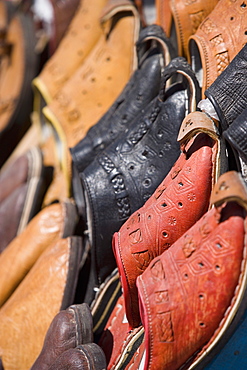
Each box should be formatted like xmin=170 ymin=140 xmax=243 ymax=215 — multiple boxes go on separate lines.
xmin=71 ymin=26 xmax=172 ymax=172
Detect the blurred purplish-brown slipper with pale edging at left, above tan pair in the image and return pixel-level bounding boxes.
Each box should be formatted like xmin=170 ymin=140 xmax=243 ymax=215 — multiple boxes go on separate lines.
xmin=0 ymin=147 xmax=51 ymax=252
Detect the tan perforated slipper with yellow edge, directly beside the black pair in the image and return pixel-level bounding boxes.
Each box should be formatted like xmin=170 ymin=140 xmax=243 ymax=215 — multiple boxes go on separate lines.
xmin=43 ymin=0 xmax=140 ymax=188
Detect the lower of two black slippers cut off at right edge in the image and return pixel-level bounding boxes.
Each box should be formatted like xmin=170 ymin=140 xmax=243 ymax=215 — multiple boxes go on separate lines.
xmin=223 ymin=108 xmax=247 ymax=161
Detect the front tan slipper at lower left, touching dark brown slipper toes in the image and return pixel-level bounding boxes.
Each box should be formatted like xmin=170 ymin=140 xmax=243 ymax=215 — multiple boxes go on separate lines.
xmin=0 ymin=237 xmax=82 ymax=370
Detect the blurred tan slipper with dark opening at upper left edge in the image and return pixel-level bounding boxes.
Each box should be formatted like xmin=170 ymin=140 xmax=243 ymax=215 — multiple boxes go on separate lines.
xmin=0 ymin=12 xmax=37 ymax=167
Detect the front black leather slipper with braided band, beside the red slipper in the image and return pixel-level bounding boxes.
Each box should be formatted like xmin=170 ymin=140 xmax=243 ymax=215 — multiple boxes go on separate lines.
xmin=81 ymin=58 xmax=201 ymax=298
